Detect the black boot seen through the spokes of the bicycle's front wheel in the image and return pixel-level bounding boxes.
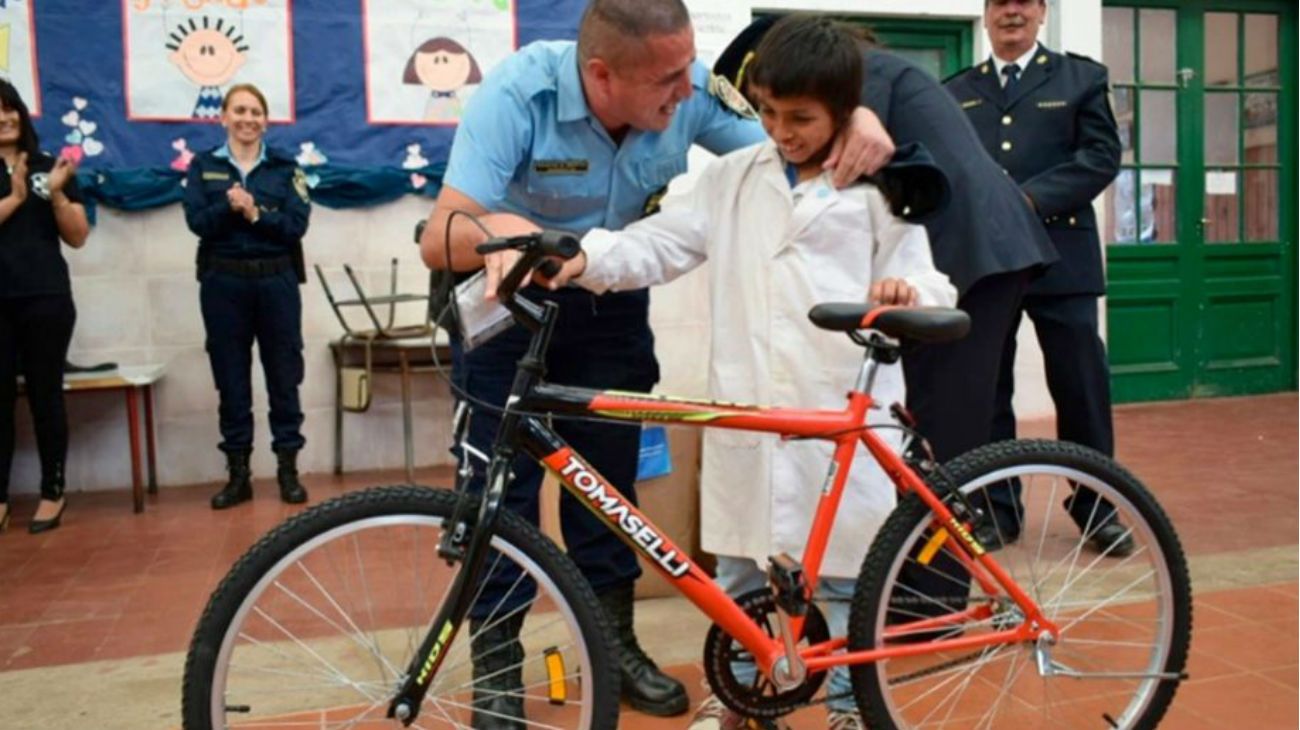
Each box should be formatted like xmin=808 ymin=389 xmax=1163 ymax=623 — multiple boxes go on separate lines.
xmin=469 ymin=612 xmax=524 ymax=730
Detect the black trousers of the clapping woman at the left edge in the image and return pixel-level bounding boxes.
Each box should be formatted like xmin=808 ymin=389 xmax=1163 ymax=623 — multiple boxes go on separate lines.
xmin=0 ymin=294 xmax=77 ymax=503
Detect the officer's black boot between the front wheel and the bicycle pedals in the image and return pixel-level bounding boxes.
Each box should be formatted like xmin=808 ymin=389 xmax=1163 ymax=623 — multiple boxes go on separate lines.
xmin=597 ymin=583 xmax=690 ymax=717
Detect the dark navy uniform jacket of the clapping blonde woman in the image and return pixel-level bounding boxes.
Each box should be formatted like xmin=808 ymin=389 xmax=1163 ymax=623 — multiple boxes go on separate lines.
xmin=185 ymin=144 xmax=311 ymax=275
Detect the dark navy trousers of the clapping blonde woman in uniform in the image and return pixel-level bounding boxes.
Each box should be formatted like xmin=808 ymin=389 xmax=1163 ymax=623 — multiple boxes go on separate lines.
xmin=199 ymin=270 xmax=306 ymax=452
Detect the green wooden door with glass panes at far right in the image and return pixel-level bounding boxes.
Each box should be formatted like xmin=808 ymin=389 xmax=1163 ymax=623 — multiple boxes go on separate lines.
xmin=1104 ymin=0 xmax=1296 ymax=401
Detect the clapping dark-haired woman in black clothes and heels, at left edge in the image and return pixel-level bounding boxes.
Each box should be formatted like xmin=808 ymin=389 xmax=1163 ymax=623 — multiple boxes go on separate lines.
xmin=0 ymin=81 xmax=90 ymax=533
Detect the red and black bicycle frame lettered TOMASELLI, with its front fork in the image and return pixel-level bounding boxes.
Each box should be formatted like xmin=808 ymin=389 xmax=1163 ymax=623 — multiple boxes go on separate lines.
xmin=389 ymin=242 xmax=1060 ymax=725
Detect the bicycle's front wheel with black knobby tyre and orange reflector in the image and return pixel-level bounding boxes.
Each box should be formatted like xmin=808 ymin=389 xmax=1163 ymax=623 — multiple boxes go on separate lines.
xmin=183 ymin=487 xmax=619 ymax=730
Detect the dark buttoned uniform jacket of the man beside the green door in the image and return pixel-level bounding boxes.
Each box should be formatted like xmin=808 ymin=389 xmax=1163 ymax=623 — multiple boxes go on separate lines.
xmin=945 ymin=45 xmax=1121 ymax=295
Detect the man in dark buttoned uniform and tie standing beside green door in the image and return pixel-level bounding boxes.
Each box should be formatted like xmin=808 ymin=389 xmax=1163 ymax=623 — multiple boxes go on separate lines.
xmin=945 ymin=0 xmax=1132 ymax=548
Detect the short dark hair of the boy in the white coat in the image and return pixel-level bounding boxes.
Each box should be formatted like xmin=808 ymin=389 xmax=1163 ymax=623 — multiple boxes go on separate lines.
xmin=745 ymin=13 xmax=863 ymax=123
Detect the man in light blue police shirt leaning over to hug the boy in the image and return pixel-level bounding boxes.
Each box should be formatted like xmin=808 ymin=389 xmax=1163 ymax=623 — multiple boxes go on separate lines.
xmin=421 ymin=0 xmax=893 ymax=729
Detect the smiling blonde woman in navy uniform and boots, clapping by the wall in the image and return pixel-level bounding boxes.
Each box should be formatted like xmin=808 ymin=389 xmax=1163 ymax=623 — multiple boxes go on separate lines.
xmin=185 ymin=84 xmax=311 ymax=509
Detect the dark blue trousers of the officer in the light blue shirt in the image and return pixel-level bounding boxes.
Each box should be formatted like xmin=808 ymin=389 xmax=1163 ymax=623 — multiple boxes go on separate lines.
xmin=455 ymin=290 xmax=659 ymax=618
